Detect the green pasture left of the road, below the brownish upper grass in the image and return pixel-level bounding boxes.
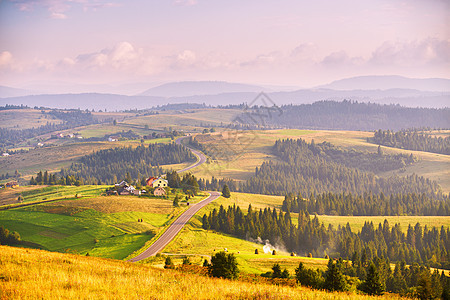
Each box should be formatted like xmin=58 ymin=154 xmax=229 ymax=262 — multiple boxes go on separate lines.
xmin=0 ymin=202 xmax=172 ymax=259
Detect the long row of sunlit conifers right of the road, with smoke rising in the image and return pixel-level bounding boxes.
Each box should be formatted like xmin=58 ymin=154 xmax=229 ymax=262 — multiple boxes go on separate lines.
xmin=202 ymin=205 xmax=450 ymax=269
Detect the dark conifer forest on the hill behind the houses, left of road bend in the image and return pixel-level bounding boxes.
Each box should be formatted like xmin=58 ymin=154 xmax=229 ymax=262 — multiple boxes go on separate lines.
xmin=60 ymin=143 xmax=195 ymax=184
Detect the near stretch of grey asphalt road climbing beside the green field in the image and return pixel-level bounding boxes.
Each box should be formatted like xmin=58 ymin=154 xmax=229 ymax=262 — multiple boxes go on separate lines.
xmin=128 ymin=192 xmax=220 ymax=262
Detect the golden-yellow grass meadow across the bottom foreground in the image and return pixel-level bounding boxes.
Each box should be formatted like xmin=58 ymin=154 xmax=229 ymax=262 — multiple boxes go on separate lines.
xmin=0 ymin=246 xmax=408 ymax=299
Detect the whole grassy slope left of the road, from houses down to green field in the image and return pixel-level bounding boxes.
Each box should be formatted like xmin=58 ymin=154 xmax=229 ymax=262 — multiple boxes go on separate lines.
xmin=0 ymin=186 xmax=205 ymax=259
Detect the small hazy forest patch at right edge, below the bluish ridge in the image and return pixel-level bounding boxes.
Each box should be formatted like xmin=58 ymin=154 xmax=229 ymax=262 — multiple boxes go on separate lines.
xmin=367 ymin=129 xmax=450 ymax=155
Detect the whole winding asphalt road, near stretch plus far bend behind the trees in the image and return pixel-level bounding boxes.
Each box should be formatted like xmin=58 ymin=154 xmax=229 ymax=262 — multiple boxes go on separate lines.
xmin=128 ymin=137 xmax=216 ymax=262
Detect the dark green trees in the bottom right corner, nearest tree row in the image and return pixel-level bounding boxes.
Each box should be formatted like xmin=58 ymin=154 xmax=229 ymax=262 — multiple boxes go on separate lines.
xmin=295 ymin=256 xmax=450 ymax=299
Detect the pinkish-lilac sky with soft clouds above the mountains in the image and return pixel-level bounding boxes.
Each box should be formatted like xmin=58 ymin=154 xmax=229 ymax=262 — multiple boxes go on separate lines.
xmin=0 ymin=0 xmax=450 ymax=92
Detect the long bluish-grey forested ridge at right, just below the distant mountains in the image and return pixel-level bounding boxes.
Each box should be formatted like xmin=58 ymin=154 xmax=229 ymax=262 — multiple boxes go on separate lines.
xmin=236 ymin=100 xmax=450 ymax=131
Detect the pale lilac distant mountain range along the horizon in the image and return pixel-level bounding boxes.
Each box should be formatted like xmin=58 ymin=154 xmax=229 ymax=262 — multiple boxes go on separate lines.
xmin=0 ymin=76 xmax=450 ymax=110
